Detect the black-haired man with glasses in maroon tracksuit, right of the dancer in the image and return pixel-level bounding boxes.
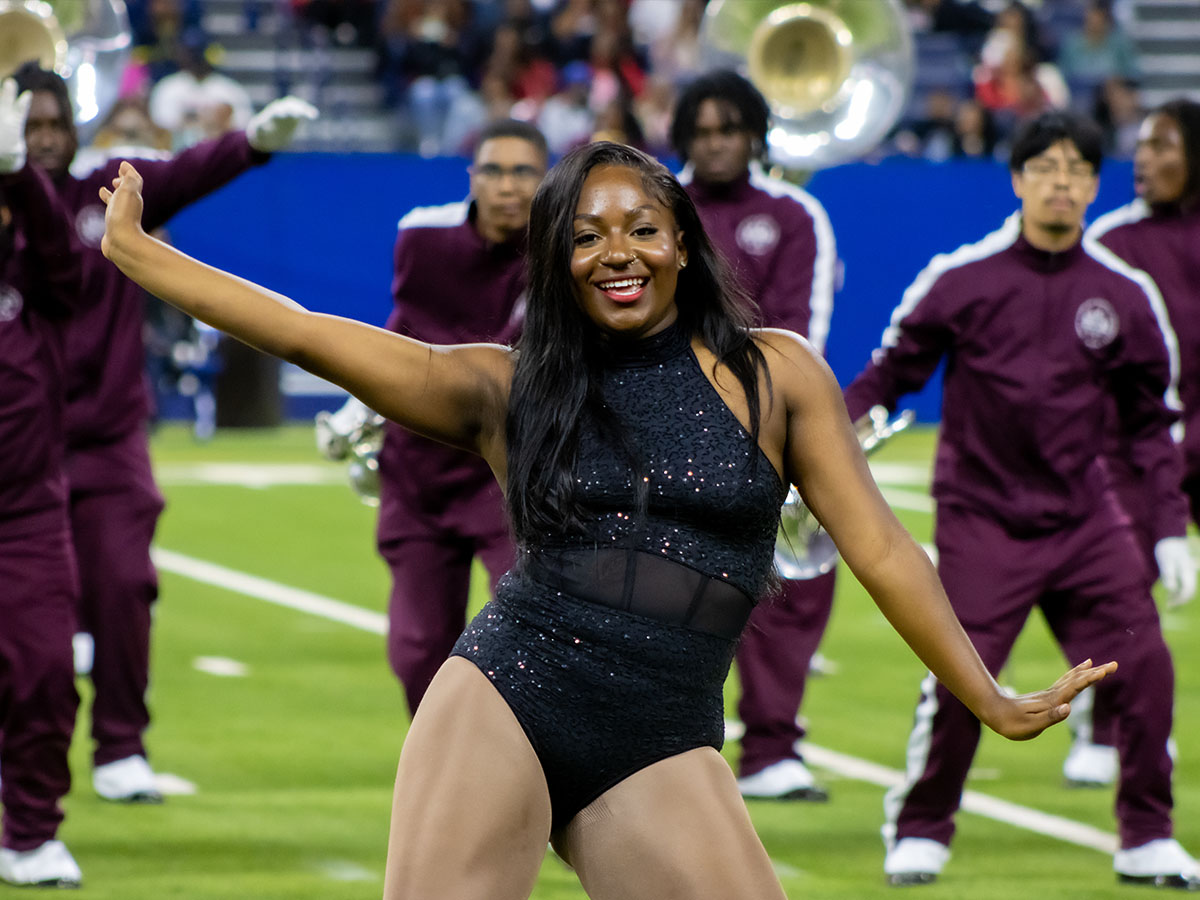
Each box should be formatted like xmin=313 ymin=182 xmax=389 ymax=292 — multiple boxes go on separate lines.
xmin=845 ymin=112 xmax=1200 ymax=890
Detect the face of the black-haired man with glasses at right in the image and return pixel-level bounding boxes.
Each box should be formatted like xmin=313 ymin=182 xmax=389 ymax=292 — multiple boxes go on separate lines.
xmin=1013 ymin=140 xmax=1100 ymax=251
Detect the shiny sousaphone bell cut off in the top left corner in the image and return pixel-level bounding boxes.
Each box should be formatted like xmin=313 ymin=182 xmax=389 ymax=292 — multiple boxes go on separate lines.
xmin=0 ymin=0 xmax=132 ymax=140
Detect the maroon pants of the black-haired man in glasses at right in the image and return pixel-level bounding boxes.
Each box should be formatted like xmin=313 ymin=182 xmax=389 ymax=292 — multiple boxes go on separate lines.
xmin=884 ymin=508 xmax=1175 ymax=847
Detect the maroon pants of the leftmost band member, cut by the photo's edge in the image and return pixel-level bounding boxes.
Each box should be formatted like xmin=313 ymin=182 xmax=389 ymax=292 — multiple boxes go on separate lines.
xmin=0 ymin=521 xmax=79 ymax=851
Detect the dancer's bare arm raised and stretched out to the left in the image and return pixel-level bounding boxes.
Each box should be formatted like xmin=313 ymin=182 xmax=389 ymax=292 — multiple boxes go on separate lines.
xmin=101 ymin=162 xmax=511 ymax=458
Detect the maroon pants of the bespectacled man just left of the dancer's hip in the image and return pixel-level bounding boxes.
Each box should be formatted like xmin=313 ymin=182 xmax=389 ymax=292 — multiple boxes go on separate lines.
xmin=379 ymin=530 xmax=515 ymax=713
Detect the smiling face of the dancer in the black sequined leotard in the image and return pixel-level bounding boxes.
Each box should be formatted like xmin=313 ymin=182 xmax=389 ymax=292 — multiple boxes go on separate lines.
xmin=571 ymin=166 xmax=688 ymax=337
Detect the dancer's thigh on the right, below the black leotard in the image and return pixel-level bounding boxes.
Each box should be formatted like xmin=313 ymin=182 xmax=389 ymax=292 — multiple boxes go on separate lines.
xmin=556 ymin=748 xmax=785 ymax=900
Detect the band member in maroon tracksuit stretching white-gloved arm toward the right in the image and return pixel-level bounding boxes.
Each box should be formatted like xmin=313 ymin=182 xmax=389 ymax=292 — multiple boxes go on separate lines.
xmin=17 ymin=64 xmax=317 ymax=803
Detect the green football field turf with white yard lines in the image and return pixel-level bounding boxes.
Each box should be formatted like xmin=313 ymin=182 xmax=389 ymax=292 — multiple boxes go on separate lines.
xmin=58 ymin=427 xmax=1200 ymax=900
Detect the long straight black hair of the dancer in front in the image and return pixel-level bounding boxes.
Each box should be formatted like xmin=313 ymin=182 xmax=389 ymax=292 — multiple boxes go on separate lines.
xmin=506 ymin=142 xmax=769 ymax=542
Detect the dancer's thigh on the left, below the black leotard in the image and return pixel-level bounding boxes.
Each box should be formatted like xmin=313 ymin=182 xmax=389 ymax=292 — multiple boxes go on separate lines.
xmin=384 ymin=656 xmax=551 ymax=900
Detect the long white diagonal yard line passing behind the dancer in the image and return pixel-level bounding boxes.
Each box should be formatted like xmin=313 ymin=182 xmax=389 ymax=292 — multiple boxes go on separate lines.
xmin=154 ymin=548 xmax=1117 ymax=853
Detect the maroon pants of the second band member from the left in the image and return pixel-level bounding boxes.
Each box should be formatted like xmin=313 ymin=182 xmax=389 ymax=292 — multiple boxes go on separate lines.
xmin=67 ymin=431 xmax=163 ymax=766
